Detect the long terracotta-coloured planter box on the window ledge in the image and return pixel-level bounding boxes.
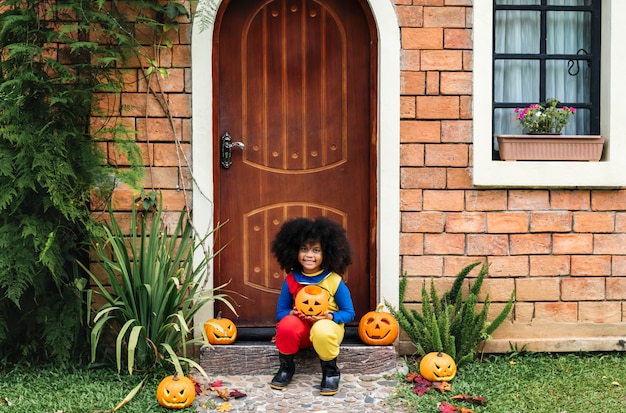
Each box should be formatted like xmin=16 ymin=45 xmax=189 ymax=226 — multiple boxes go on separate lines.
xmin=496 ymin=135 xmax=604 ymax=162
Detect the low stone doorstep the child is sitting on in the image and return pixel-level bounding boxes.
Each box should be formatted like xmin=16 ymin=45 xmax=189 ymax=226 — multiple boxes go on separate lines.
xmin=199 ymin=341 xmax=397 ymax=376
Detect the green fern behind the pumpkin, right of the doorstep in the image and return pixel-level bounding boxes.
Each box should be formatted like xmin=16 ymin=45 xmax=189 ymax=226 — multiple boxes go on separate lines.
xmin=385 ymin=262 xmax=515 ymax=367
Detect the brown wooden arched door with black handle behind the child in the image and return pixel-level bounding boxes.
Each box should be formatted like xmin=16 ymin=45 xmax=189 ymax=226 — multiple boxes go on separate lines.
xmin=213 ymin=0 xmax=377 ymax=327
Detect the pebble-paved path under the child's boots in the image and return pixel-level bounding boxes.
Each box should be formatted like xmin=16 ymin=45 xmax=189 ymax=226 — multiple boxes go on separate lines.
xmin=196 ymin=360 xmax=406 ymax=413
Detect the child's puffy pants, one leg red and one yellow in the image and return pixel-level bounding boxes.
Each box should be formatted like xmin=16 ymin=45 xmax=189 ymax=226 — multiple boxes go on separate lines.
xmin=276 ymin=315 xmax=344 ymax=361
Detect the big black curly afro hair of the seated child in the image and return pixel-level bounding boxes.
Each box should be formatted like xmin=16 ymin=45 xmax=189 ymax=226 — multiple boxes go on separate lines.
xmin=272 ymin=217 xmax=352 ymax=274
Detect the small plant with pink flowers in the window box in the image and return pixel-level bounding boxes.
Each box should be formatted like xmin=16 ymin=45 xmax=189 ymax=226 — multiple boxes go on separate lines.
xmin=515 ymin=98 xmax=576 ymax=133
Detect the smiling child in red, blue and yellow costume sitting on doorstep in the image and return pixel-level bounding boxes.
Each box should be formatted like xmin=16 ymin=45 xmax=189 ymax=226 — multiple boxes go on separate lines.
xmin=270 ymin=217 xmax=355 ymax=396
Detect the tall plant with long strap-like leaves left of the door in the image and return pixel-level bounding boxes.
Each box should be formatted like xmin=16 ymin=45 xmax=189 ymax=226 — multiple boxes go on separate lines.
xmin=78 ymin=198 xmax=236 ymax=375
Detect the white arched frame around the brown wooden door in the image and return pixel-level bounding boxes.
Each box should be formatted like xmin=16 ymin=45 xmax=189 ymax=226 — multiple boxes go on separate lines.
xmin=191 ymin=0 xmax=401 ymax=332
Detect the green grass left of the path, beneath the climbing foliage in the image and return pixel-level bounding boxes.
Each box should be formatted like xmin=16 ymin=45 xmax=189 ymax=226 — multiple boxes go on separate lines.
xmin=0 ymin=366 xmax=196 ymax=413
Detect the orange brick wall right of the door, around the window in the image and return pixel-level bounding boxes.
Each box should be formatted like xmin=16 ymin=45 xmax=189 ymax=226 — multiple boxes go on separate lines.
xmin=395 ymin=0 xmax=626 ymax=352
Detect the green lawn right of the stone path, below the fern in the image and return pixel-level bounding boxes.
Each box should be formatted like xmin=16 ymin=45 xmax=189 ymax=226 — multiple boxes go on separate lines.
xmin=391 ymin=353 xmax=626 ymax=413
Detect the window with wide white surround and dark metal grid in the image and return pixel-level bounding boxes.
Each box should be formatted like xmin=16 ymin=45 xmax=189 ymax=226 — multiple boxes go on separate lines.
xmin=473 ymin=0 xmax=626 ymax=187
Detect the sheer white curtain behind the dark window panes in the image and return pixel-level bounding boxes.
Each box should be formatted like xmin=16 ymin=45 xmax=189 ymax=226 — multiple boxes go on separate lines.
xmin=493 ymin=0 xmax=591 ymax=135
